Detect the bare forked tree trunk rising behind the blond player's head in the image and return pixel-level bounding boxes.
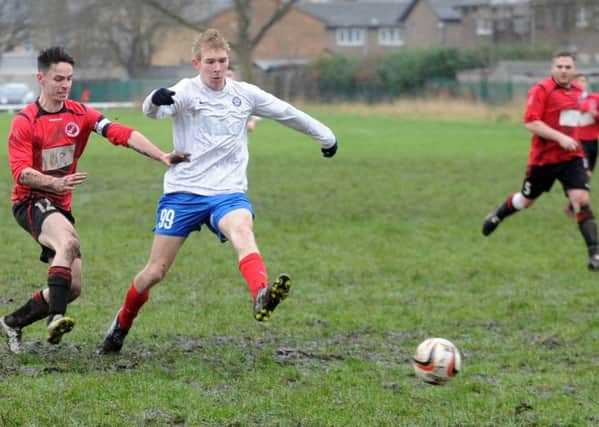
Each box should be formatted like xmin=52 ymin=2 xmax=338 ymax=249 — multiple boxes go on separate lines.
xmin=142 ymin=0 xmax=298 ymax=82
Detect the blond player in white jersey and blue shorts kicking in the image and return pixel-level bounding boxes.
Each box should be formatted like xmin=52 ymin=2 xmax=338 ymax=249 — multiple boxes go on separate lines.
xmin=101 ymin=29 xmax=337 ymax=354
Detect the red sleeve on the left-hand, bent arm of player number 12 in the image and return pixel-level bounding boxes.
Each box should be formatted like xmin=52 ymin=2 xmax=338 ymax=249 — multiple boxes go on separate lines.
xmin=8 ymin=113 xmax=33 ymax=183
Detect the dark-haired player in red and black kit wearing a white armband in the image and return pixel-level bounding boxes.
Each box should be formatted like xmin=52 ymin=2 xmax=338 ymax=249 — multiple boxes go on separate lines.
xmin=0 ymin=47 xmax=187 ymax=353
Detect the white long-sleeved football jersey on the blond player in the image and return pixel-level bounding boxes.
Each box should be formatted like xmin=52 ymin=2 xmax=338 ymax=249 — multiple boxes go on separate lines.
xmin=143 ymin=75 xmax=335 ymax=196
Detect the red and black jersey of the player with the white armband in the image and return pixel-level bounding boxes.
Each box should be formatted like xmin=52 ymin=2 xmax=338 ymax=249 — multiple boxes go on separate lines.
xmin=8 ymin=100 xmax=133 ymax=211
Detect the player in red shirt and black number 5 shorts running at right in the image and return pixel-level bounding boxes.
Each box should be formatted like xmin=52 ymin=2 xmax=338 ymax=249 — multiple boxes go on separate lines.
xmin=482 ymin=52 xmax=599 ymax=270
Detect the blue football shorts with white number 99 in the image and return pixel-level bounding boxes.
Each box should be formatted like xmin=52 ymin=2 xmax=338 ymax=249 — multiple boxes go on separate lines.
xmin=154 ymin=193 xmax=254 ymax=242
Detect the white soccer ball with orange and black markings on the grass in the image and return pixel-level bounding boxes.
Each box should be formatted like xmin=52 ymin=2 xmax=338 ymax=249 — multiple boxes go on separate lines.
xmin=412 ymin=338 xmax=462 ymax=384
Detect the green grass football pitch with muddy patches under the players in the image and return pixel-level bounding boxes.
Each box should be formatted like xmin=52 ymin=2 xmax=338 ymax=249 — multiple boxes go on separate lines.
xmin=0 ymin=108 xmax=599 ymax=426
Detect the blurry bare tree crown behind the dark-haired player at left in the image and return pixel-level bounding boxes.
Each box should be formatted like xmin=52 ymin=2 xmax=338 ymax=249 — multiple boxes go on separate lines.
xmin=30 ymin=0 xmax=192 ymax=78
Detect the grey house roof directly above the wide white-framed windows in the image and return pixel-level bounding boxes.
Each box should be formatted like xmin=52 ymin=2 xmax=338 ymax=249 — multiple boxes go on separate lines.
xmin=295 ymin=0 xmax=413 ymax=27
